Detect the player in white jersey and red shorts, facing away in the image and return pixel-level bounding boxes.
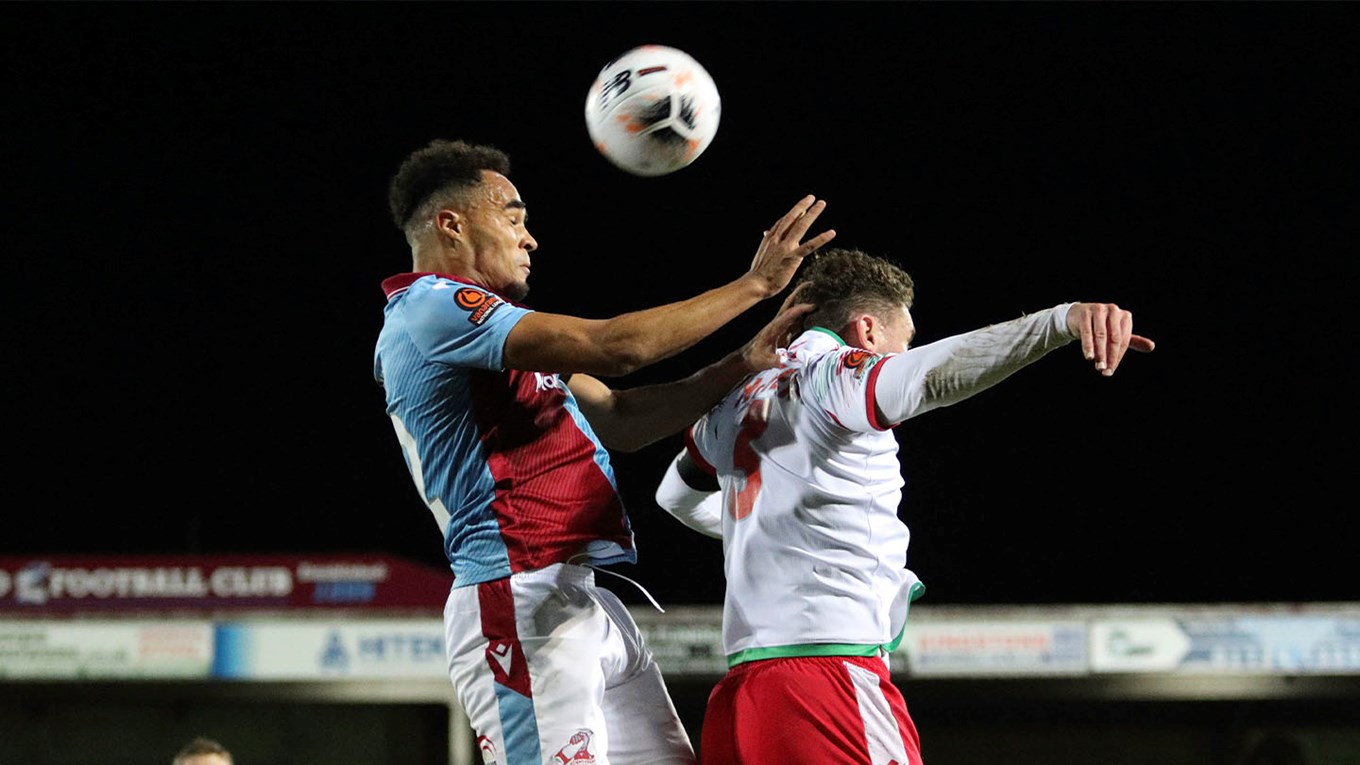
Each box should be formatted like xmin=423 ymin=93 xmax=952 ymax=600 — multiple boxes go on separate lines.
xmin=657 ymin=249 xmax=1153 ymax=765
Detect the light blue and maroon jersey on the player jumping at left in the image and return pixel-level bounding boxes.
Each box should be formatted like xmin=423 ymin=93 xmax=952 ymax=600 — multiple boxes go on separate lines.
xmin=373 ymin=274 xmax=636 ymax=587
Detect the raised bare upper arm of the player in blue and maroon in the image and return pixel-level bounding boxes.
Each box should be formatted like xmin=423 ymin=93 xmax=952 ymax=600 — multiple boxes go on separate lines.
xmin=505 ymin=195 xmax=835 ymax=377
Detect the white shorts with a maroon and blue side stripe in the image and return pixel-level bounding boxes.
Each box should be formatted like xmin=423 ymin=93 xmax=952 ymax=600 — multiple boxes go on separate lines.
xmin=443 ymin=564 xmax=695 ymax=765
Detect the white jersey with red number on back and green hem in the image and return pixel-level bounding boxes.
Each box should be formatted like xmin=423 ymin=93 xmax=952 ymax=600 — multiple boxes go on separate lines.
xmin=685 ymin=304 xmax=1072 ymax=664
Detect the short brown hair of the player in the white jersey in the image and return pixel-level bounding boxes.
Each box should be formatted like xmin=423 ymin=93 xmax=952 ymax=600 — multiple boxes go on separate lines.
xmin=798 ymin=248 xmax=917 ymax=329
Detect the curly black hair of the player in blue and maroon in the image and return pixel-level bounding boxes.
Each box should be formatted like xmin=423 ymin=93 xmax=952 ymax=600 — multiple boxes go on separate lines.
xmin=388 ymin=139 xmax=510 ymax=231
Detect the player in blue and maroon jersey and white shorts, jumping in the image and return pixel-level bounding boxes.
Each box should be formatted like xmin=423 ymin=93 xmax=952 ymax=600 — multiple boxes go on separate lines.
xmin=374 ymin=140 xmax=835 ymax=765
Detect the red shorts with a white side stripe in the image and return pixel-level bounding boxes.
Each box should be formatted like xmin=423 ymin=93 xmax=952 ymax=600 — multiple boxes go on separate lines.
xmin=699 ymin=647 xmax=922 ymax=765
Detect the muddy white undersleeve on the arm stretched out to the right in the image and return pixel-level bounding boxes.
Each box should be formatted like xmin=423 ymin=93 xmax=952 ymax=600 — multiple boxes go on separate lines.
xmin=874 ymin=304 xmax=1074 ymax=423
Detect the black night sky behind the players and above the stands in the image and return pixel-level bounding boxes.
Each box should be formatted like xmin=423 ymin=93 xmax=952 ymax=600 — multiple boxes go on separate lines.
xmin=0 ymin=3 xmax=1360 ymax=604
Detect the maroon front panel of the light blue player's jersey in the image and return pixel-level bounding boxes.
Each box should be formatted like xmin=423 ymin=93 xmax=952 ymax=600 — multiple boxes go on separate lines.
xmin=471 ymin=370 xmax=632 ymax=572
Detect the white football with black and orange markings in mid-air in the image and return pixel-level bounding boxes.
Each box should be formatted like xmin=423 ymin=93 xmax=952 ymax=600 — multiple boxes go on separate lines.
xmin=586 ymin=45 xmax=722 ymax=176
